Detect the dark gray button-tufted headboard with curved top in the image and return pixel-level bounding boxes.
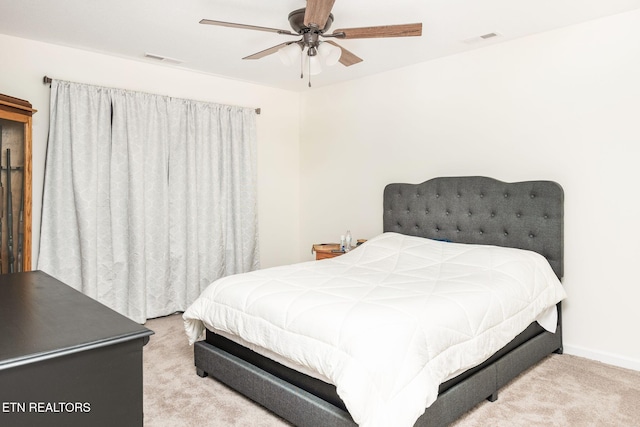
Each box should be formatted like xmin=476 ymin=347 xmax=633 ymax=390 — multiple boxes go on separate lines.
xmin=383 ymin=177 xmax=564 ymax=278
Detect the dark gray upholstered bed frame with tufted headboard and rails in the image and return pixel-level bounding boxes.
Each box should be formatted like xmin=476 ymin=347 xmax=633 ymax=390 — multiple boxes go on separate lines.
xmin=194 ymin=177 xmax=564 ymax=427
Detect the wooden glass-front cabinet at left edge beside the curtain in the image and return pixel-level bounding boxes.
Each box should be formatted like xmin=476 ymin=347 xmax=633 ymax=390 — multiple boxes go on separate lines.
xmin=0 ymin=94 xmax=36 ymax=273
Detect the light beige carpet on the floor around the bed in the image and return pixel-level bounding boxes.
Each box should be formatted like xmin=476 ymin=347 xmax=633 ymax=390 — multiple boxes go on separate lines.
xmin=144 ymin=314 xmax=640 ymax=427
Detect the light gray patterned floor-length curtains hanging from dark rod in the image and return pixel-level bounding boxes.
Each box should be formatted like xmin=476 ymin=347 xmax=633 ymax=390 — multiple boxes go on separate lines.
xmin=38 ymin=80 xmax=259 ymax=323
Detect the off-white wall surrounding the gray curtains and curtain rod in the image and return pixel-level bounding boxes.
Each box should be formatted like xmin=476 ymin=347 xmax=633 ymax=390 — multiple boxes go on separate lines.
xmin=0 ymin=35 xmax=300 ymax=267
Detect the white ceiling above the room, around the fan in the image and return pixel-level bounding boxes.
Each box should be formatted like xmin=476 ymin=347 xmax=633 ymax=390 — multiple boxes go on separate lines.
xmin=0 ymin=0 xmax=640 ymax=91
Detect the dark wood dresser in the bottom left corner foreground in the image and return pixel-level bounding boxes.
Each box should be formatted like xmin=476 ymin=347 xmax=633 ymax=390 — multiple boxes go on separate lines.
xmin=0 ymin=271 xmax=153 ymax=427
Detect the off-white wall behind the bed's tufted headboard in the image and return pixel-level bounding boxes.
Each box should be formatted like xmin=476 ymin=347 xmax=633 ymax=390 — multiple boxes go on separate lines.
xmin=300 ymin=11 xmax=640 ymax=370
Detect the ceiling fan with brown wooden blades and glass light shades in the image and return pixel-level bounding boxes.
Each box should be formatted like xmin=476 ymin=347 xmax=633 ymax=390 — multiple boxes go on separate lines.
xmin=200 ymin=0 xmax=422 ymax=86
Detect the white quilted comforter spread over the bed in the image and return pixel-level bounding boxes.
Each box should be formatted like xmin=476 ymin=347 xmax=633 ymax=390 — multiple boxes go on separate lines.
xmin=184 ymin=233 xmax=565 ymax=427
